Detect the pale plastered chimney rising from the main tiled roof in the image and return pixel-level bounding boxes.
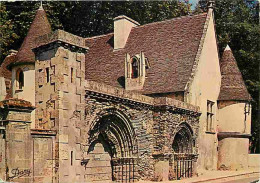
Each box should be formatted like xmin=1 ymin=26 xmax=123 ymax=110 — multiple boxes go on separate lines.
xmin=114 ymin=15 xmax=140 ymax=49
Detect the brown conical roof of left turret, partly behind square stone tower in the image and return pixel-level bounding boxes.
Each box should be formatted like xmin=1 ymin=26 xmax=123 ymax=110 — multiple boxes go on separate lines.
xmin=11 ymin=6 xmax=51 ymax=65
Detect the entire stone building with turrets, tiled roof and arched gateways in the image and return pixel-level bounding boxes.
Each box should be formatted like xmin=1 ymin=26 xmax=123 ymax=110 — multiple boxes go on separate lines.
xmin=0 ymin=3 xmax=251 ymax=183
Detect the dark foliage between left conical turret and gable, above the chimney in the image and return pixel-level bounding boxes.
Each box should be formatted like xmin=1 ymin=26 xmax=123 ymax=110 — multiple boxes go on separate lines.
xmin=47 ymin=1 xmax=190 ymax=37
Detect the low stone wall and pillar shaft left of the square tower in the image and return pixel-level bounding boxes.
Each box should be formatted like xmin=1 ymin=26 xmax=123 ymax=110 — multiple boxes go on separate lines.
xmin=0 ymin=108 xmax=56 ymax=182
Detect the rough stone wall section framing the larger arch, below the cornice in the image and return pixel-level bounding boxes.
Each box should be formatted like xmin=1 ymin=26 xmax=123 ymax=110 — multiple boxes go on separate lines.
xmin=84 ymin=94 xmax=153 ymax=180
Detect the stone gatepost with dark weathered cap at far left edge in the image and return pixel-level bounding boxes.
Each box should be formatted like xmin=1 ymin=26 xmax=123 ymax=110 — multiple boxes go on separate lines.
xmin=0 ymin=99 xmax=34 ymax=182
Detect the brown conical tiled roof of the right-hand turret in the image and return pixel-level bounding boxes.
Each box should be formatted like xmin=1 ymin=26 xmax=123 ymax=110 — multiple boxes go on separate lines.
xmin=218 ymin=45 xmax=251 ymax=101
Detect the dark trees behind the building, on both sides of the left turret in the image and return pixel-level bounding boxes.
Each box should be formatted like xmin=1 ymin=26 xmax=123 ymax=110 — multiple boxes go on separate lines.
xmin=1 ymin=0 xmax=191 ymax=61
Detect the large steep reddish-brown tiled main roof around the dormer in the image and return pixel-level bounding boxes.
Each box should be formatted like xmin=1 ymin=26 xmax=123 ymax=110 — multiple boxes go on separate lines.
xmin=86 ymin=13 xmax=207 ymax=94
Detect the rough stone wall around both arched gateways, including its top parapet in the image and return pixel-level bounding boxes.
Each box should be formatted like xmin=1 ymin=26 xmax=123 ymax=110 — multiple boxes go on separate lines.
xmin=84 ymin=82 xmax=199 ymax=180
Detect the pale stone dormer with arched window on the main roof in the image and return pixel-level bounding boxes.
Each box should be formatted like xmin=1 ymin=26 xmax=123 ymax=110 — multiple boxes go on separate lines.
xmin=125 ymin=52 xmax=148 ymax=90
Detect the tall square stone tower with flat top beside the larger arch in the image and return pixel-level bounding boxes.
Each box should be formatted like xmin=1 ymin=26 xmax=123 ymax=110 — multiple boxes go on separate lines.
xmin=33 ymin=30 xmax=87 ymax=182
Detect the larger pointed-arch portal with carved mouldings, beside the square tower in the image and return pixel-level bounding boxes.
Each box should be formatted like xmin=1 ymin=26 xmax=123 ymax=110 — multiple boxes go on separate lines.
xmin=87 ymin=109 xmax=137 ymax=182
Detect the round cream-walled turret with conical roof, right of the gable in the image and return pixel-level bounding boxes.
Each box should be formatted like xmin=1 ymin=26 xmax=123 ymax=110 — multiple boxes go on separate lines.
xmin=218 ymin=45 xmax=251 ymax=170
